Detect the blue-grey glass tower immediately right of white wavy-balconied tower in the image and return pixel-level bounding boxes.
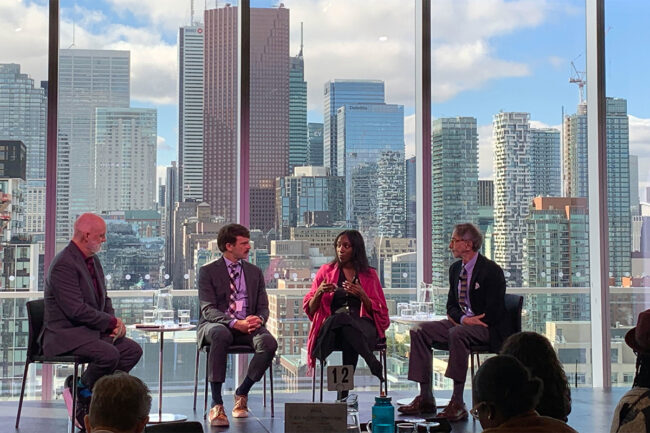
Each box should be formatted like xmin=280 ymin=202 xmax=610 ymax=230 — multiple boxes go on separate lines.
xmin=530 ymin=128 xmax=562 ymax=197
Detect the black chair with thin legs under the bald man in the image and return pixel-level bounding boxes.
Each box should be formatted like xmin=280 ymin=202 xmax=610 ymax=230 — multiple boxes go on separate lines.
xmin=16 ymin=299 xmax=90 ymax=433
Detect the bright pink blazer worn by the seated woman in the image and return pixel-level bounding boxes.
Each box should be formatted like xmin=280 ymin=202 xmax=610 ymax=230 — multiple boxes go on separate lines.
xmin=302 ymin=263 xmax=390 ymax=373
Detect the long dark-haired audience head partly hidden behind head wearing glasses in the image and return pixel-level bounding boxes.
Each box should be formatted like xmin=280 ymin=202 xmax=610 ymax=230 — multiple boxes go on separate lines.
xmin=501 ymin=332 xmax=571 ymax=422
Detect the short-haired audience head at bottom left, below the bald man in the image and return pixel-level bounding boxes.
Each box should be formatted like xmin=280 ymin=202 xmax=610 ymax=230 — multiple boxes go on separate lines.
xmin=85 ymin=372 xmax=151 ymax=433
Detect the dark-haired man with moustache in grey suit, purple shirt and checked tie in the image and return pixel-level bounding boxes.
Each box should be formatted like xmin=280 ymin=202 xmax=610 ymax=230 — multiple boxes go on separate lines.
xmin=197 ymin=224 xmax=278 ymax=426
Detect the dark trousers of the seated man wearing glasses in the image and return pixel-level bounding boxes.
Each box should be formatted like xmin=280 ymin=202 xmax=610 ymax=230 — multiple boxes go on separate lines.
xmin=408 ymin=319 xmax=490 ymax=383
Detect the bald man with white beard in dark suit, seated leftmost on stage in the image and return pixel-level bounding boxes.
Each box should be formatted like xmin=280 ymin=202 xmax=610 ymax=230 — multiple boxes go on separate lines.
xmin=42 ymin=213 xmax=142 ymax=428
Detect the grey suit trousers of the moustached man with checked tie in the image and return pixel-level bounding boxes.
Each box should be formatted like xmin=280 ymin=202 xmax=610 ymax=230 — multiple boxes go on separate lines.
xmin=205 ymin=323 xmax=278 ymax=383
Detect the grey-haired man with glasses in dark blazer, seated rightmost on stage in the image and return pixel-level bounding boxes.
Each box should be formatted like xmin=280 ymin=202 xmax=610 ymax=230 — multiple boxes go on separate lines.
xmin=398 ymin=223 xmax=512 ymax=421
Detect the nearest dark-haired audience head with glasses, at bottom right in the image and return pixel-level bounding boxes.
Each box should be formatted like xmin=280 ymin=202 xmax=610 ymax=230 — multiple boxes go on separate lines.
xmin=471 ymin=355 xmax=543 ymax=429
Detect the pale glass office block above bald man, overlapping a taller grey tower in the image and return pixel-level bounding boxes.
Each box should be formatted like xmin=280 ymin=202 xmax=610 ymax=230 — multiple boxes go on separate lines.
xmin=93 ymin=108 xmax=158 ymax=213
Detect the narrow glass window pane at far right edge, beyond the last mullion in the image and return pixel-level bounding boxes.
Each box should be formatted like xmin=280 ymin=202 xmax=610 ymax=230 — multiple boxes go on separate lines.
xmin=604 ymin=0 xmax=650 ymax=387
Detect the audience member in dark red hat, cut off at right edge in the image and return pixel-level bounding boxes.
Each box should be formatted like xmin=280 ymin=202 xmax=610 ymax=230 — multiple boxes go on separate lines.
xmin=611 ymin=310 xmax=650 ymax=433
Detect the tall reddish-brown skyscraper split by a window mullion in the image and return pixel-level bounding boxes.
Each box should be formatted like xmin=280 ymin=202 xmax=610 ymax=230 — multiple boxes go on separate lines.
xmin=203 ymin=5 xmax=289 ymax=230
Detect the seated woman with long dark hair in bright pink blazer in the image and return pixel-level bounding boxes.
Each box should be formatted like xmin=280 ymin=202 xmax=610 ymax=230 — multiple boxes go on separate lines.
xmin=303 ymin=230 xmax=390 ymax=400
